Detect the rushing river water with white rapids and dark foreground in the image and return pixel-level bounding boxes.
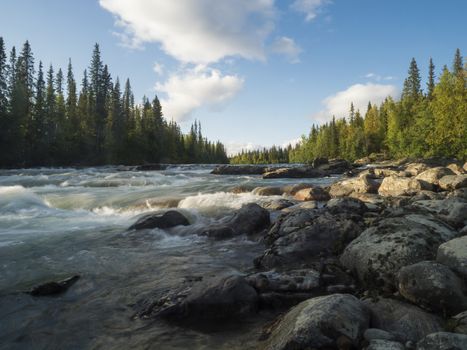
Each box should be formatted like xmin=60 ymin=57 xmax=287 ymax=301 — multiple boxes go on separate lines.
xmin=0 ymin=166 xmax=338 ymax=349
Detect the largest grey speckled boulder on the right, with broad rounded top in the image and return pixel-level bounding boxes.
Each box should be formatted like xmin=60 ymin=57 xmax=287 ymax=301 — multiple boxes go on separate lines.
xmin=340 ymin=210 xmax=457 ymax=292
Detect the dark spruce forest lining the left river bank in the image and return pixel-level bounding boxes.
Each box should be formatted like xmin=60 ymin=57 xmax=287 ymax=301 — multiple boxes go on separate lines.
xmin=0 ymin=37 xmax=228 ymax=167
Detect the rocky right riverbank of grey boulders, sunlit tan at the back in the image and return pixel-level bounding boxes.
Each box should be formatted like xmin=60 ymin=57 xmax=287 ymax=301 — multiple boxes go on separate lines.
xmin=126 ymin=162 xmax=467 ymax=350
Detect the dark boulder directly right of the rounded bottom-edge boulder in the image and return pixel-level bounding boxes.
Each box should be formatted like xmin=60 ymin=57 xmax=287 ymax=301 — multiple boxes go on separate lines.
xmin=364 ymin=298 xmax=443 ymax=343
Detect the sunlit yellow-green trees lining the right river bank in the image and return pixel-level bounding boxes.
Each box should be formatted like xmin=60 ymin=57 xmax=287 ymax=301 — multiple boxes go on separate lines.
xmin=232 ymin=49 xmax=467 ymax=163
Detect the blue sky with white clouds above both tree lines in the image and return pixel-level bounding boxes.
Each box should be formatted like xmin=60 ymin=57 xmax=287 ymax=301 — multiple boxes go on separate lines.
xmin=0 ymin=0 xmax=467 ymax=153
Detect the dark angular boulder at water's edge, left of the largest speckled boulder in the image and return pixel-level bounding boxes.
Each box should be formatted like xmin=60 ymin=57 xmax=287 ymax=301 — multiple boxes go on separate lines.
xmin=255 ymin=208 xmax=363 ymax=268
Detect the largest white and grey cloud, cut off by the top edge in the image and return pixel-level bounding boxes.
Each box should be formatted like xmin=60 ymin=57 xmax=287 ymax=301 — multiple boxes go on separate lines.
xmin=99 ymin=0 xmax=276 ymax=64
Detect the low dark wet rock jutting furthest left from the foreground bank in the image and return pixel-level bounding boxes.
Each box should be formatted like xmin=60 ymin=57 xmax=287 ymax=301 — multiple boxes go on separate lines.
xmin=137 ymin=276 xmax=258 ymax=322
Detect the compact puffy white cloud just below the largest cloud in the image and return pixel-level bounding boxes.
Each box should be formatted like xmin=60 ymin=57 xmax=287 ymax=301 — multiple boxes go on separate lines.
xmin=156 ymin=65 xmax=243 ymax=121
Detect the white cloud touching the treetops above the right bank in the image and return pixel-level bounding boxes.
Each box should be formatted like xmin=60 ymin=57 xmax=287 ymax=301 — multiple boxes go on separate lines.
xmin=312 ymin=83 xmax=398 ymax=123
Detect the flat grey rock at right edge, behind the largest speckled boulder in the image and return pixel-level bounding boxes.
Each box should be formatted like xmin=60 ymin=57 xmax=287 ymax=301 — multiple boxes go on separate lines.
xmin=412 ymin=197 xmax=467 ymax=228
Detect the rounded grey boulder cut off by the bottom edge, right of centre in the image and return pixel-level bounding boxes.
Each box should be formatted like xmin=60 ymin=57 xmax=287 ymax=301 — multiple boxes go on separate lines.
xmin=262 ymin=294 xmax=369 ymax=350
